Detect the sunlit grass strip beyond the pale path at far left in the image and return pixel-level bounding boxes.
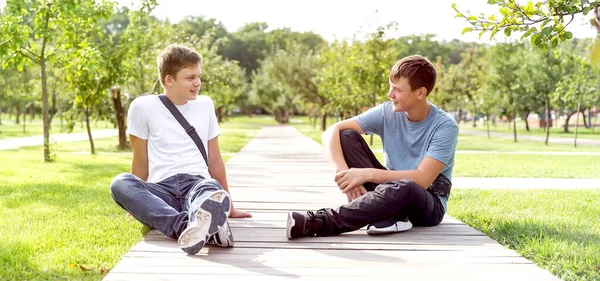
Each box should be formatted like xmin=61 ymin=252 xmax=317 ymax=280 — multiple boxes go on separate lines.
xmin=0 ymin=115 xmax=114 ymax=140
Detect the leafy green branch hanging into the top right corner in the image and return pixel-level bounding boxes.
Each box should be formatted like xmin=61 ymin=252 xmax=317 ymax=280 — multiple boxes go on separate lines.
xmin=452 ymin=0 xmax=600 ymax=50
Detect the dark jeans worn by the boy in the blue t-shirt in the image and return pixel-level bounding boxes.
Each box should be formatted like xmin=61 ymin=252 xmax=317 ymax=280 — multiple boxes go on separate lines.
xmin=317 ymin=130 xmax=445 ymax=236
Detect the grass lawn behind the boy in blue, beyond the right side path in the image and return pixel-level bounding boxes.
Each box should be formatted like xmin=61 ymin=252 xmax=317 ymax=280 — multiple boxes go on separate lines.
xmin=292 ymin=119 xmax=600 ymax=178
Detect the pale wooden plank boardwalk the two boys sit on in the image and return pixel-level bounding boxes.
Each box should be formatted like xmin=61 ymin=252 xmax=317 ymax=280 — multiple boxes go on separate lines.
xmin=104 ymin=126 xmax=560 ymax=281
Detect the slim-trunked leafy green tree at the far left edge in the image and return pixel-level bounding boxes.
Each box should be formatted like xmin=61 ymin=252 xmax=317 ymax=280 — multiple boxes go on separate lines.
xmin=0 ymin=0 xmax=112 ymax=162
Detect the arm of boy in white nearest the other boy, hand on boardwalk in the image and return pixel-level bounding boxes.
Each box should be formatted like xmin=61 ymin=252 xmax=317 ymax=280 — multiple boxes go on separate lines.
xmin=208 ymin=137 xmax=252 ymax=218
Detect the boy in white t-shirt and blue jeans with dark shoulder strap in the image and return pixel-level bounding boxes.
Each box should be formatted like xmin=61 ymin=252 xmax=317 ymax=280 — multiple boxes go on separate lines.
xmin=110 ymin=44 xmax=251 ymax=255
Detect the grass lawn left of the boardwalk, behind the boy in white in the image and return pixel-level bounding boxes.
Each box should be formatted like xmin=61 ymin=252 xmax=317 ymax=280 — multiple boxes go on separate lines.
xmin=0 ymin=115 xmax=273 ymax=281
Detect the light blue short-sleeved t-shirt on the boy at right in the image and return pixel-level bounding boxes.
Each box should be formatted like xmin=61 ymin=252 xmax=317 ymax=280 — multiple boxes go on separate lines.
xmin=354 ymin=101 xmax=458 ymax=212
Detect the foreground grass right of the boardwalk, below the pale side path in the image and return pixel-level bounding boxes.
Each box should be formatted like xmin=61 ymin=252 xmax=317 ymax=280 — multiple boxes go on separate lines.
xmin=448 ymin=189 xmax=600 ymax=281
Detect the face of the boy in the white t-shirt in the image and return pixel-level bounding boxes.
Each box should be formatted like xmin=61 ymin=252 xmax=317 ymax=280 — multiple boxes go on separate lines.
xmin=165 ymin=64 xmax=202 ymax=101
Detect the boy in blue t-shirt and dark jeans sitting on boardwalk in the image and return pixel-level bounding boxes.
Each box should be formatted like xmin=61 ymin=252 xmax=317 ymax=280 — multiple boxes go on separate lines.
xmin=287 ymin=55 xmax=458 ymax=236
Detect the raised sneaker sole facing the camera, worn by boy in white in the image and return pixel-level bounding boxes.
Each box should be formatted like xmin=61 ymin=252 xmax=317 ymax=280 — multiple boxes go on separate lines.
xmin=177 ymin=190 xmax=231 ymax=250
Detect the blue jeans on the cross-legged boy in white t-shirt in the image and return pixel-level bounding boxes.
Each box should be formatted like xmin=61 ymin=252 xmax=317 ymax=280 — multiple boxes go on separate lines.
xmin=110 ymin=173 xmax=223 ymax=239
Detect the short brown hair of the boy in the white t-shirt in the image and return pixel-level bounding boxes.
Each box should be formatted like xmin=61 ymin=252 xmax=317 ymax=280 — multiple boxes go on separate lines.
xmin=156 ymin=44 xmax=202 ymax=86
